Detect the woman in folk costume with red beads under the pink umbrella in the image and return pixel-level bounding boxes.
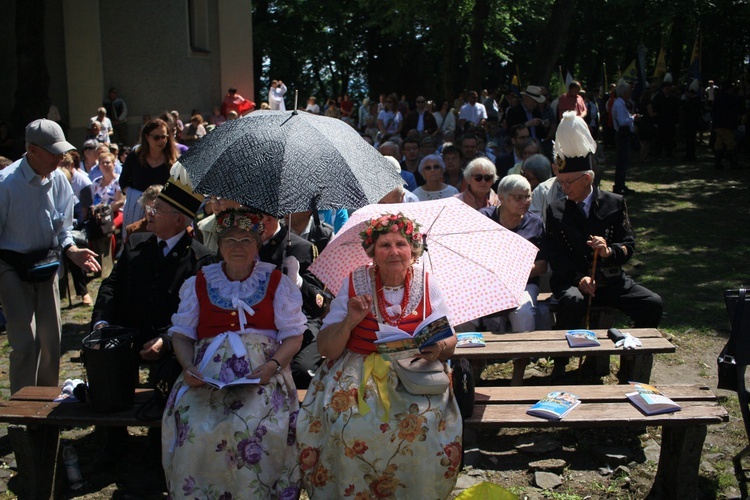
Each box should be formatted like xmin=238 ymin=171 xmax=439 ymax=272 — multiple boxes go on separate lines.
xmin=298 ymin=214 xmax=462 ymax=499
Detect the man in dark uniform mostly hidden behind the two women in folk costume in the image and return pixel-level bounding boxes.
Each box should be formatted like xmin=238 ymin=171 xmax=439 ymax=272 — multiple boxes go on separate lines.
xmin=259 ymin=210 xmax=326 ymax=389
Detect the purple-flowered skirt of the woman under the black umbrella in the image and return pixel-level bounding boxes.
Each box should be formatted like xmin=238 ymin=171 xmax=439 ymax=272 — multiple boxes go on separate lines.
xmin=162 ymin=332 xmax=300 ymax=499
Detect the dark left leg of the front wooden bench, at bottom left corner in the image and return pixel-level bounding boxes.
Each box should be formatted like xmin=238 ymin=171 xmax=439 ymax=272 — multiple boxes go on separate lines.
xmin=8 ymin=425 xmax=60 ymax=498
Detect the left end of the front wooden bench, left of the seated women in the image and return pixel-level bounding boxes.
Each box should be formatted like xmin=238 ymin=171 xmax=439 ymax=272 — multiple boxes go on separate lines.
xmin=0 ymin=387 xmax=161 ymax=498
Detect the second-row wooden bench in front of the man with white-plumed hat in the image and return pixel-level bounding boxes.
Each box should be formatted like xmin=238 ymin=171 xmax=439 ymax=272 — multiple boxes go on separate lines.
xmin=454 ymin=328 xmax=676 ymax=383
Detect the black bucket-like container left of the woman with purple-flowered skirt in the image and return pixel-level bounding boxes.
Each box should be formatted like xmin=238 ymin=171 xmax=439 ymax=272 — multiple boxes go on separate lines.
xmin=83 ymin=326 xmax=138 ymax=413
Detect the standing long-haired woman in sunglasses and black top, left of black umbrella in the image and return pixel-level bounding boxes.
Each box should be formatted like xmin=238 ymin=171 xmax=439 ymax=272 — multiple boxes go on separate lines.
xmin=120 ymin=118 xmax=178 ymax=241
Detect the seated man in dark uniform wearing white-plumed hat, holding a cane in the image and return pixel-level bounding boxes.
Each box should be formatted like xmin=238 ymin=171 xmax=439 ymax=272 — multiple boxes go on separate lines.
xmin=546 ymin=114 xmax=664 ymax=377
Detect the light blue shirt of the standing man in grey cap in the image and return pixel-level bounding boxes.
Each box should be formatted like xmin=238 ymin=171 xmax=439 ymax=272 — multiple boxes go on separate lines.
xmin=0 ymin=156 xmax=74 ymax=253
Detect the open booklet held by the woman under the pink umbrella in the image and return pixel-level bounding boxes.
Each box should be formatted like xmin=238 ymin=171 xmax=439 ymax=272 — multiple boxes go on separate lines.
xmin=375 ymin=314 xmax=453 ymax=361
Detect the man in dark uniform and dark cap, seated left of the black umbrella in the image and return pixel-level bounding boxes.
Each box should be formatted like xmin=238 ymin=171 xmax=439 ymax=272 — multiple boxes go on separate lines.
xmin=91 ymin=179 xmax=216 ymax=376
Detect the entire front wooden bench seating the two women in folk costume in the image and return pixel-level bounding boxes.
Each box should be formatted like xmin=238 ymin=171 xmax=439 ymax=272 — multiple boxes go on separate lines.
xmin=0 ymin=385 xmax=728 ymax=498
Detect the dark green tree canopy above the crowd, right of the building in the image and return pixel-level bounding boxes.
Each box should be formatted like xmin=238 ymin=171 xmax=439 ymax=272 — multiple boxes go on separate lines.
xmin=253 ymin=0 xmax=750 ymax=103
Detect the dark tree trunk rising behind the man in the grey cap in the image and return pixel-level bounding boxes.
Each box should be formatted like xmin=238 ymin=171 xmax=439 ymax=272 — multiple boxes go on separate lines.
xmin=11 ymin=0 xmax=50 ymax=139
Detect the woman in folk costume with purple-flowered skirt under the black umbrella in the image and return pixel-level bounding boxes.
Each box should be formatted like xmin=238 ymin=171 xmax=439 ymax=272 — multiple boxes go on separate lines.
xmin=162 ymin=208 xmax=306 ymax=499
